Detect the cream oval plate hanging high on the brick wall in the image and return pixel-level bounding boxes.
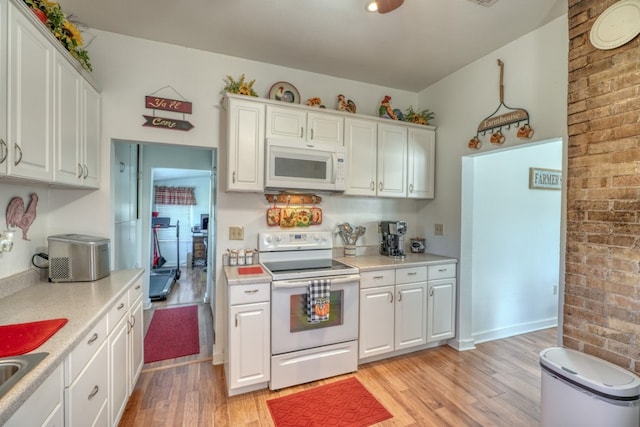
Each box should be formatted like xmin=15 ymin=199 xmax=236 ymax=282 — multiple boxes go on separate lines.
xmin=589 ymin=0 xmax=640 ymax=50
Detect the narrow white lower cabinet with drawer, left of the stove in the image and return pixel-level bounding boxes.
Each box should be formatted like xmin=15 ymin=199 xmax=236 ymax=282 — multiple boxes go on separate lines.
xmin=224 ymin=283 xmax=271 ymax=396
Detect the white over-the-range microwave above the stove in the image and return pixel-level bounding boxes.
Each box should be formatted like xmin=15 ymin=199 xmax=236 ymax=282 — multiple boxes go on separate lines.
xmin=265 ymin=138 xmax=347 ymax=191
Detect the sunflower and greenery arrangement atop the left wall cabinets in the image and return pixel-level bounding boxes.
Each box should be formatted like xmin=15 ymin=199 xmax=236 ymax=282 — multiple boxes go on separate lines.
xmin=24 ymin=0 xmax=93 ymax=71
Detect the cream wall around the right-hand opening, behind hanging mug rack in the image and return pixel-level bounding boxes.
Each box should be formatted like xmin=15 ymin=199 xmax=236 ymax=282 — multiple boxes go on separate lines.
xmin=417 ymin=15 xmax=569 ymax=348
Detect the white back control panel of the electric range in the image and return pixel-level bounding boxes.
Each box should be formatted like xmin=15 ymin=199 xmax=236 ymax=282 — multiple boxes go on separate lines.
xmin=258 ymin=231 xmax=333 ymax=252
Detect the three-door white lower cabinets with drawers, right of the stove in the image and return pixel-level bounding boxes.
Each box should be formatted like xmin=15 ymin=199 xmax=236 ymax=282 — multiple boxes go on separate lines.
xmin=358 ymin=264 xmax=456 ymax=360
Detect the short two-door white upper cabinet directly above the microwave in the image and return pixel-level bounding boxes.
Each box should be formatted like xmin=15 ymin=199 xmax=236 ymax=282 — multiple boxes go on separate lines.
xmin=266 ymin=105 xmax=344 ymax=145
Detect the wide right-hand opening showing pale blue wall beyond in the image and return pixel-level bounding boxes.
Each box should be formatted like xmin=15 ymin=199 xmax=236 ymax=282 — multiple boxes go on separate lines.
xmin=459 ymin=139 xmax=563 ymax=348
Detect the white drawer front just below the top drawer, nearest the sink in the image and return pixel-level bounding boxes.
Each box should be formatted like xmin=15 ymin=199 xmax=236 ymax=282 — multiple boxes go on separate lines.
xmin=65 ymin=342 xmax=108 ymax=427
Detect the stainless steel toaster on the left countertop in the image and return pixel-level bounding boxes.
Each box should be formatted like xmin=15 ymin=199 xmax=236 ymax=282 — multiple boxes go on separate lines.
xmin=48 ymin=234 xmax=111 ymax=282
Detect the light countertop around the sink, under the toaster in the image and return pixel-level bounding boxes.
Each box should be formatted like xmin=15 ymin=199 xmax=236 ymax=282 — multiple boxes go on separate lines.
xmin=0 ymin=269 xmax=144 ymax=425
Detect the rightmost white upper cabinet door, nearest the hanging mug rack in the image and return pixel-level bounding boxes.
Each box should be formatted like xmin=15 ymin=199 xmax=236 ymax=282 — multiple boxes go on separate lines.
xmin=407 ymin=128 xmax=436 ymax=199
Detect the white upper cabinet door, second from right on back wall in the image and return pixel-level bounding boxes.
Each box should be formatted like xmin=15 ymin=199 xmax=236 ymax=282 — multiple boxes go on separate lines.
xmin=378 ymin=123 xmax=407 ymax=197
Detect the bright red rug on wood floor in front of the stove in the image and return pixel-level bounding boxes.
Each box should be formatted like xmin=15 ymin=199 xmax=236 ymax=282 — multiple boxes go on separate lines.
xmin=267 ymin=377 xmax=392 ymax=427
